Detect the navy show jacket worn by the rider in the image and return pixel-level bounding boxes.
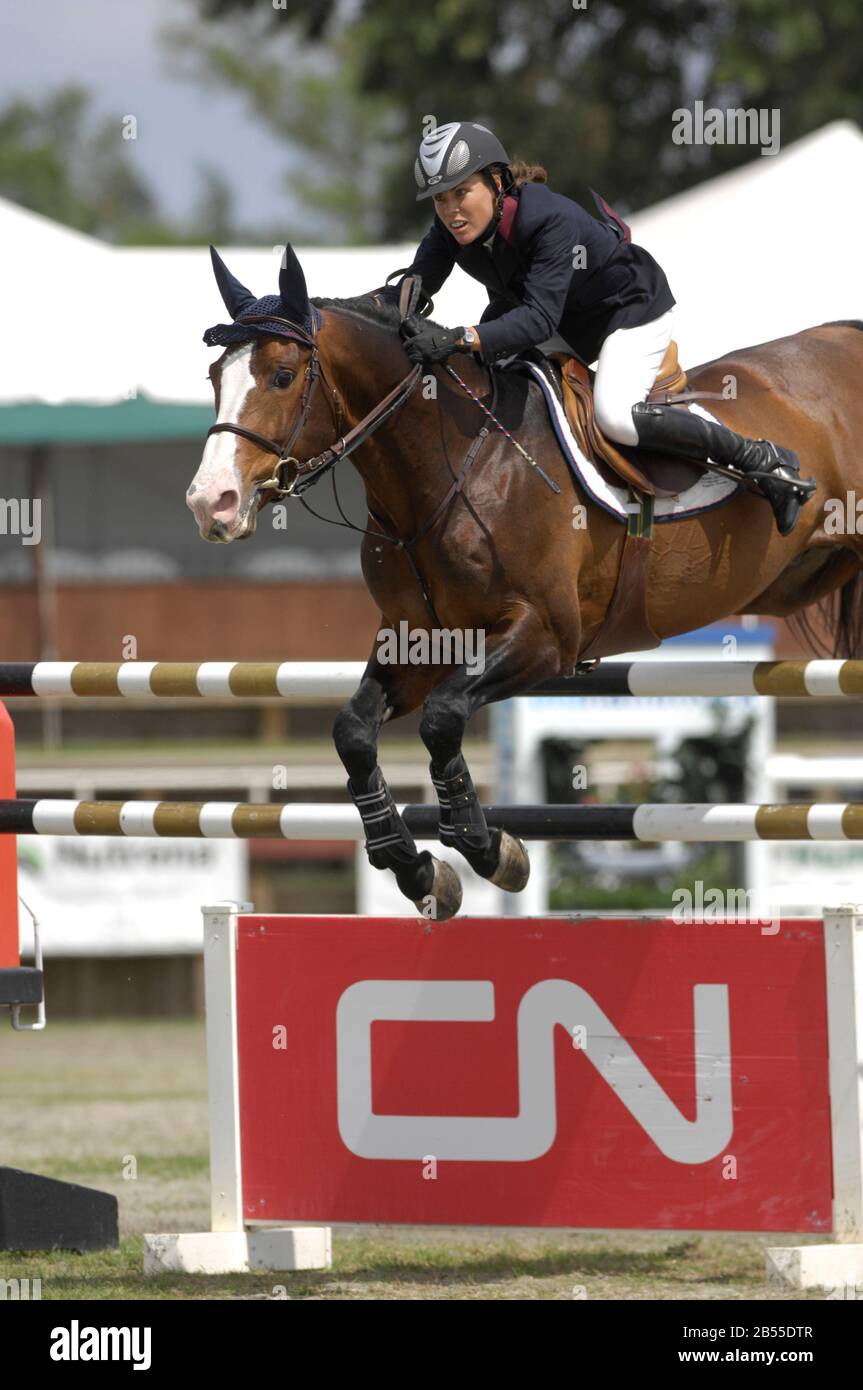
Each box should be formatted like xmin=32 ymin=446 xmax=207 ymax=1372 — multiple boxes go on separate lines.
xmin=409 ymin=183 xmax=674 ymax=364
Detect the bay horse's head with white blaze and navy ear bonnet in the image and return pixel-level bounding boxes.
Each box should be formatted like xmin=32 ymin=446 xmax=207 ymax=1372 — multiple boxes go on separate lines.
xmin=186 ymin=246 xmax=340 ymax=542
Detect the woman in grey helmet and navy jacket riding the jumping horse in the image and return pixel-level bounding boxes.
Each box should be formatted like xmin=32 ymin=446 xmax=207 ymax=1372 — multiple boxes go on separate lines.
xmin=389 ymin=121 xmax=814 ymax=535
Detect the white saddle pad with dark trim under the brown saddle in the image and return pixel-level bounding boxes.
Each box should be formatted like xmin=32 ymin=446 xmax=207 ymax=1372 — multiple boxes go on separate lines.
xmin=495 ymin=357 xmax=742 ymax=523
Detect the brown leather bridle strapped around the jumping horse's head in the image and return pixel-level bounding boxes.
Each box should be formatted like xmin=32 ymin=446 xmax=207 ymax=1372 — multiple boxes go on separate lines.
xmin=207 ymin=314 xmax=422 ymax=498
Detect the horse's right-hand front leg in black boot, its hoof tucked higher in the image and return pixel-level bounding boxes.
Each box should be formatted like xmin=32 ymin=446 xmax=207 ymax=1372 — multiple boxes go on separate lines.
xmin=420 ymin=609 xmax=560 ymax=892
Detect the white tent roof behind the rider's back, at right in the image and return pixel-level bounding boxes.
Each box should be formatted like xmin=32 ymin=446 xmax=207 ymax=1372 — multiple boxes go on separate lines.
xmin=631 ymin=121 xmax=863 ymax=366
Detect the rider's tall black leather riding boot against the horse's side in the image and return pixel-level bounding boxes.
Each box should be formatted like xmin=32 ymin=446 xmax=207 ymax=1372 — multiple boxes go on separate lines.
xmin=632 ymin=400 xmax=816 ymax=535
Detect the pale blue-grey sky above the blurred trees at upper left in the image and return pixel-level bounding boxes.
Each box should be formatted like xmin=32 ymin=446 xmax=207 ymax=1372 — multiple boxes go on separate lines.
xmin=0 ymin=0 xmax=302 ymax=225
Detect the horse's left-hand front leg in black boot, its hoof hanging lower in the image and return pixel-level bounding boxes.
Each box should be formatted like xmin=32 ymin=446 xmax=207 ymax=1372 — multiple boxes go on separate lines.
xmin=332 ymin=656 xmax=461 ymax=920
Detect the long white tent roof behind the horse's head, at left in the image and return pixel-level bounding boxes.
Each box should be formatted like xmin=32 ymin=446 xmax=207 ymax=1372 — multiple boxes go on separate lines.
xmin=0 ymin=199 xmax=485 ymax=406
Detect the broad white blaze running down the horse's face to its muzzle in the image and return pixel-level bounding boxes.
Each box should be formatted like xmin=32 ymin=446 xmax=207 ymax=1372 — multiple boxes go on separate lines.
xmin=186 ymin=343 xmax=256 ymax=541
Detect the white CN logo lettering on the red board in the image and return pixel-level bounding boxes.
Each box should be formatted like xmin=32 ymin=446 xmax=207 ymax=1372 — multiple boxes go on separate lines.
xmin=336 ymin=980 xmax=734 ymax=1163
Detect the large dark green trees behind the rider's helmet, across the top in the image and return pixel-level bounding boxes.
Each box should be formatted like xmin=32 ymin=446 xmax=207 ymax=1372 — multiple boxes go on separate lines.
xmin=173 ymin=0 xmax=863 ymax=240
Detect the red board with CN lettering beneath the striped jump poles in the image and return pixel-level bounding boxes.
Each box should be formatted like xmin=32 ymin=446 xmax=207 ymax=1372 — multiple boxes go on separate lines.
xmin=238 ymin=916 xmax=831 ymax=1232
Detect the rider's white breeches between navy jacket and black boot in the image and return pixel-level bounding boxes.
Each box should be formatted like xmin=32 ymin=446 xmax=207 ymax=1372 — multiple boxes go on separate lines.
xmin=593 ymin=309 xmax=674 ymax=445
